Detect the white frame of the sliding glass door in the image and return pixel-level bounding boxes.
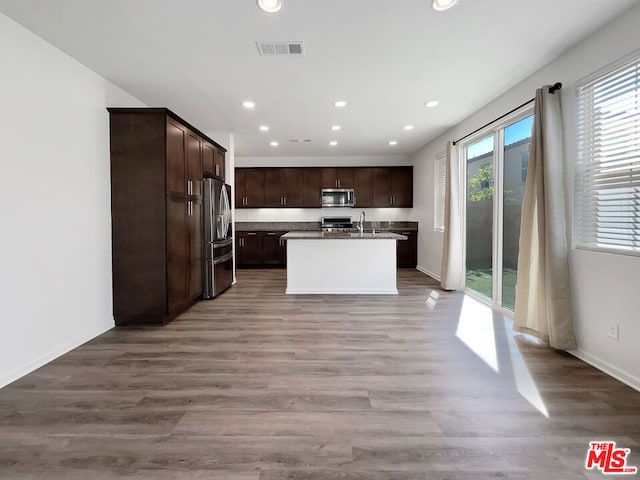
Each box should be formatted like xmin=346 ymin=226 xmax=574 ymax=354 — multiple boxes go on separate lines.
xmin=457 ymin=103 xmax=534 ymax=318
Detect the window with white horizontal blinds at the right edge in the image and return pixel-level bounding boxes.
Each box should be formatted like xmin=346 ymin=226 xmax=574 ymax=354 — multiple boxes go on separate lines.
xmin=574 ymin=52 xmax=640 ymax=255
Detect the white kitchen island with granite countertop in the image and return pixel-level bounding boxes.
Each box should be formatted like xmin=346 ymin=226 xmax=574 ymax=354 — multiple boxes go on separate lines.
xmin=282 ymin=231 xmax=407 ymax=295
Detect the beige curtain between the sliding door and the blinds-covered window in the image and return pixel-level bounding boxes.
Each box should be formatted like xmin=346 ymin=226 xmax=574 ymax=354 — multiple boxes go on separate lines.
xmin=514 ymin=86 xmax=576 ymax=350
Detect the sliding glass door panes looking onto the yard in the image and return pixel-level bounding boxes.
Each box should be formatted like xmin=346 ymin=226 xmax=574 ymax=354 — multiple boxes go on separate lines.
xmin=463 ymin=111 xmax=533 ymax=310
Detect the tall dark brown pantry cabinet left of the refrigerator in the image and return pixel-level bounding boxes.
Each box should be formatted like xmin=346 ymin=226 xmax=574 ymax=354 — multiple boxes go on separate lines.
xmin=108 ymin=108 xmax=225 ymax=325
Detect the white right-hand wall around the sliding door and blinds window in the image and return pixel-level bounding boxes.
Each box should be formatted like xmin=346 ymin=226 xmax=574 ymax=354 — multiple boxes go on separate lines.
xmin=412 ymin=6 xmax=640 ymax=389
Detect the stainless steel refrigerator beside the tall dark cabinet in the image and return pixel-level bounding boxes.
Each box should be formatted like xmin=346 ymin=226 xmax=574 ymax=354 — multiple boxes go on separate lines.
xmin=203 ymin=178 xmax=233 ymax=298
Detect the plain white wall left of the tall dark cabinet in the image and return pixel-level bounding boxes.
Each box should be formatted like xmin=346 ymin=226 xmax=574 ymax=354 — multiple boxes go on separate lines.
xmin=0 ymin=14 xmax=142 ymax=386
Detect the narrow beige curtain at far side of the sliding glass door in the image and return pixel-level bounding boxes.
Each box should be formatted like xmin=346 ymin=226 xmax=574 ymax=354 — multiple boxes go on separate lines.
xmin=440 ymin=142 xmax=464 ymax=290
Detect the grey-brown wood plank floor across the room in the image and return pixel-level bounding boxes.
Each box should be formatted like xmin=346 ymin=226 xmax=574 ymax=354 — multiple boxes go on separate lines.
xmin=0 ymin=270 xmax=640 ymax=480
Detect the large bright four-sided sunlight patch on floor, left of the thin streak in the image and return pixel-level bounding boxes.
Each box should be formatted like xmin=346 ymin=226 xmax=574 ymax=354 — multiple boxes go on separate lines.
xmin=456 ymin=295 xmax=500 ymax=372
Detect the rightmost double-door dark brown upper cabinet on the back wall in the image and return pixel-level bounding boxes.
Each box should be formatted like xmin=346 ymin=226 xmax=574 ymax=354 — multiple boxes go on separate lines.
xmin=372 ymin=167 xmax=413 ymax=208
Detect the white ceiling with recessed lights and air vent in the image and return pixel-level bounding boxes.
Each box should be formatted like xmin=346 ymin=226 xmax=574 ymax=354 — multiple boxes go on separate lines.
xmin=0 ymin=0 xmax=638 ymax=156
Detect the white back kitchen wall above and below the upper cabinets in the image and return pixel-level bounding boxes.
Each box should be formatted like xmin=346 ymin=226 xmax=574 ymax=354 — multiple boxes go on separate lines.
xmin=235 ymin=155 xmax=415 ymax=222
